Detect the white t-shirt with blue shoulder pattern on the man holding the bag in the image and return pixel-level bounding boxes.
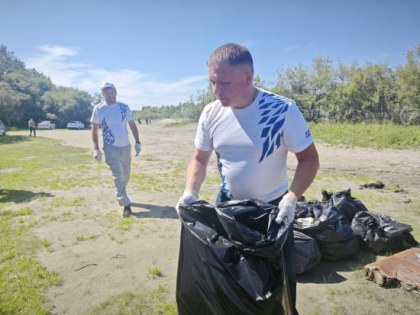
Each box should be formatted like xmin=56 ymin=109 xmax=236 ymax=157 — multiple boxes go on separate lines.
xmin=195 ymin=89 xmax=313 ymax=202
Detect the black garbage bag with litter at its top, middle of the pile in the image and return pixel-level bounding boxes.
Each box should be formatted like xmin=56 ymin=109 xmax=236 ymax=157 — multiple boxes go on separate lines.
xmin=294 ymin=207 xmax=360 ymax=261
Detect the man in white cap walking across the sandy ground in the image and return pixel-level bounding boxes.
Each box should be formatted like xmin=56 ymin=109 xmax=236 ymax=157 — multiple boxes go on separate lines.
xmin=90 ymin=82 xmax=141 ymax=217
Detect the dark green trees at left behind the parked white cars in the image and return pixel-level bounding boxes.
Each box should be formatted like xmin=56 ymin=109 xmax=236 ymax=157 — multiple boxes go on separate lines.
xmin=0 ymin=45 xmax=95 ymax=127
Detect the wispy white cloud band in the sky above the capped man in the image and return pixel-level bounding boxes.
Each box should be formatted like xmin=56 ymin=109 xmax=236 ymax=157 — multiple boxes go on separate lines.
xmin=25 ymin=45 xmax=207 ymax=109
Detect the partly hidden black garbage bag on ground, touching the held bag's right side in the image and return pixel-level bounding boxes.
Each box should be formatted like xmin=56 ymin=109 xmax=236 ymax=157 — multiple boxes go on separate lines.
xmin=293 ymin=231 xmax=321 ymax=274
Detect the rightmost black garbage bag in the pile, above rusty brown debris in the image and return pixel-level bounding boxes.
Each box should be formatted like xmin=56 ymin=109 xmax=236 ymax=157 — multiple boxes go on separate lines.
xmin=351 ymin=211 xmax=418 ymax=254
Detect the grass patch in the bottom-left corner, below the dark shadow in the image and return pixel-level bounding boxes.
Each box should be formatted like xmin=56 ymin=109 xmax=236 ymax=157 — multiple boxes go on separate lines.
xmin=0 ymin=210 xmax=61 ymax=314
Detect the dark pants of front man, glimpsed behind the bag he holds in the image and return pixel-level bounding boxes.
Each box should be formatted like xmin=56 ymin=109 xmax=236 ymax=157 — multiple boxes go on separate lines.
xmin=217 ymin=192 xmax=299 ymax=315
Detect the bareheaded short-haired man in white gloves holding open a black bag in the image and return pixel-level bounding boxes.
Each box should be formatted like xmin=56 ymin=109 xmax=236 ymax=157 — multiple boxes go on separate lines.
xmin=177 ymin=44 xmax=319 ymax=314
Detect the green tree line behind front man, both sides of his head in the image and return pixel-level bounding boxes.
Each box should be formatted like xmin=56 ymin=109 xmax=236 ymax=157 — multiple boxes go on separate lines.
xmin=136 ymin=44 xmax=420 ymax=125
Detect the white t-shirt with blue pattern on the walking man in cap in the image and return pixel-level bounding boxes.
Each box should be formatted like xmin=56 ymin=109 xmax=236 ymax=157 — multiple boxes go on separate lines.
xmin=90 ymin=102 xmax=134 ymax=147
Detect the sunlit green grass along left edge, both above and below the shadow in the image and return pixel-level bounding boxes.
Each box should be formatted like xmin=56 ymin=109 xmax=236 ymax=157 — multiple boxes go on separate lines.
xmin=0 ymin=135 xmax=98 ymax=315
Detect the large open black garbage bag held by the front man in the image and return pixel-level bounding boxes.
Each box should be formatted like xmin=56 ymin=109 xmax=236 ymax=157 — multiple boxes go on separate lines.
xmin=176 ymin=200 xmax=290 ymax=315
